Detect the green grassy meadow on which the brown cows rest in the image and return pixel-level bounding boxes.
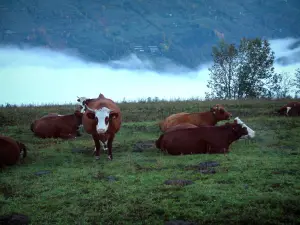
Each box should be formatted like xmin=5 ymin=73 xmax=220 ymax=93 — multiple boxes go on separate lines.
xmin=0 ymin=99 xmax=300 ymax=225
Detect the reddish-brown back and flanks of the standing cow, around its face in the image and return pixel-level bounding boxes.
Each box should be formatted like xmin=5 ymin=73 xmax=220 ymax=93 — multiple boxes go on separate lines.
xmin=82 ymin=96 xmax=122 ymax=134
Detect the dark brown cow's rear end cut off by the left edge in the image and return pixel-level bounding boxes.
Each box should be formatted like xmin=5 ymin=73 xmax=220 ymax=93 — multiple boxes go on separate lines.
xmin=0 ymin=135 xmax=27 ymax=168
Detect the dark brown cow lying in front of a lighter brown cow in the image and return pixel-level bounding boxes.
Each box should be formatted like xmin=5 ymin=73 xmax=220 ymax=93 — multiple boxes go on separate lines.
xmin=155 ymin=120 xmax=248 ymax=155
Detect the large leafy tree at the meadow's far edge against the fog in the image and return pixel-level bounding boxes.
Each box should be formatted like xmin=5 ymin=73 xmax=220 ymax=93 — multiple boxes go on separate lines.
xmin=206 ymin=38 xmax=276 ymax=99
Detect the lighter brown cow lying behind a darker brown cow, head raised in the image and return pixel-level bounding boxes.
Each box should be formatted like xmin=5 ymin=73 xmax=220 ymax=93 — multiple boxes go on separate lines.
xmin=159 ymin=104 xmax=232 ymax=132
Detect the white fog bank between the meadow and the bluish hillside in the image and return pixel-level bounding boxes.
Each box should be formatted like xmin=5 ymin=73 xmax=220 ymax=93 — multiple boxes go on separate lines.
xmin=0 ymin=38 xmax=300 ymax=105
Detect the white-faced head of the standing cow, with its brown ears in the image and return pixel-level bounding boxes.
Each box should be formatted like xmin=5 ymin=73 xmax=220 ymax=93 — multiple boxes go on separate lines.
xmin=85 ymin=105 xmax=119 ymax=134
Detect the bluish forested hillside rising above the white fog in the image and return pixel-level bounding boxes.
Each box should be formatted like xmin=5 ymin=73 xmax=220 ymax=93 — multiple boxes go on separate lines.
xmin=0 ymin=0 xmax=300 ymax=67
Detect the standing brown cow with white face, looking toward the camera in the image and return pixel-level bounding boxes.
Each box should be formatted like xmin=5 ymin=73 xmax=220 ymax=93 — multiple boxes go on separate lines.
xmin=82 ymin=94 xmax=122 ymax=160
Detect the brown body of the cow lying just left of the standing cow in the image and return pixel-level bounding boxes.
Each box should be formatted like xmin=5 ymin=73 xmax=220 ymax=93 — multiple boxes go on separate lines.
xmin=30 ymin=110 xmax=83 ymax=139
